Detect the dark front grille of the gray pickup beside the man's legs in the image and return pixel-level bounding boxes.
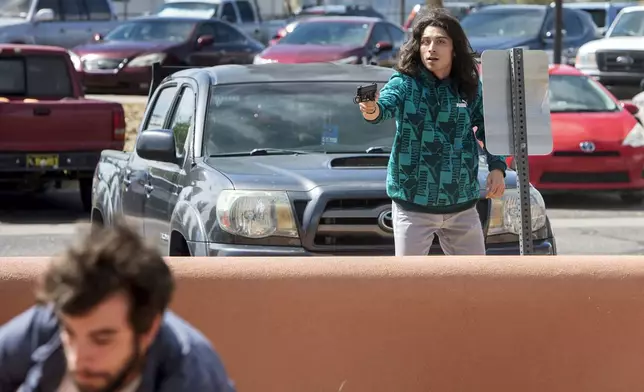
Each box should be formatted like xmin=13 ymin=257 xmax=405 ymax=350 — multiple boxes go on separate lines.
xmin=312 ymin=199 xmax=489 ymax=253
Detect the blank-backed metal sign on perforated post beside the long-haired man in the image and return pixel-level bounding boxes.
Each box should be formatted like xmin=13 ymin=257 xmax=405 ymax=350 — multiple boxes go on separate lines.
xmin=481 ymin=48 xmax=552 ymax=255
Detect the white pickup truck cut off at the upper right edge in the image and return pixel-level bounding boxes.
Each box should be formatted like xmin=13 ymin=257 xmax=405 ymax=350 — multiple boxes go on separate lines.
xmin=575 ymin=6 xmax=644 ymax=89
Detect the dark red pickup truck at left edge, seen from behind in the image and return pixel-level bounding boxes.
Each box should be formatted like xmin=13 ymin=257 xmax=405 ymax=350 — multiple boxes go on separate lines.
xmin=0 ymin=44 xmax=125 ymax=209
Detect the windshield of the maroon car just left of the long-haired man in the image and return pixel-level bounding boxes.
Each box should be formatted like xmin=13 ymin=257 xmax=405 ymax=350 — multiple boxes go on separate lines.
xmin=278 ymin=21 xmax=371 ymax=46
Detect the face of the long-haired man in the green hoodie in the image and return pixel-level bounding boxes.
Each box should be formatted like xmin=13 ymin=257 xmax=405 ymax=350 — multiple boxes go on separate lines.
xmin=420 ymin=26 xmax=454 ymax=74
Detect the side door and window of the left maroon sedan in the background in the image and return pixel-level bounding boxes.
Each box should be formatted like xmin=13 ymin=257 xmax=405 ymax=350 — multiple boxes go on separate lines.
xmin=188 ymin=20 xmax=254 ymax=66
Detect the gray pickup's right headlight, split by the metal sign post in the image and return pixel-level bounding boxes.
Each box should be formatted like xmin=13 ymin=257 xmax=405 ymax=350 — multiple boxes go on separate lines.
xmin=488 ymin=188 xmax=547 ymax=235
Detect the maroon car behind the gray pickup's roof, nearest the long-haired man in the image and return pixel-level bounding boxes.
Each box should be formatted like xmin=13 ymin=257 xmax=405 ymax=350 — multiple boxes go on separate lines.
xmin=254 ymin=16 xmax=405 ymax=67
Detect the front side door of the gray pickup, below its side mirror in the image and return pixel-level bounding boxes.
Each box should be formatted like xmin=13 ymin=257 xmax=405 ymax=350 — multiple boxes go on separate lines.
xmin=144 ymin=82 xmax=197 ymax=255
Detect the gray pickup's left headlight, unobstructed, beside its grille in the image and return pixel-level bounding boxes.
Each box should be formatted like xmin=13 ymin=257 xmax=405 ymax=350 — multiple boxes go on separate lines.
xmin=217 ymin=190 xmax=298 ymax=238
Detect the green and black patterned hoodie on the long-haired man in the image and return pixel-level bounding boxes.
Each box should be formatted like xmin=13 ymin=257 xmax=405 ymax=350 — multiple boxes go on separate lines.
xmin=368 ymin=70 xmax=507 ymax=214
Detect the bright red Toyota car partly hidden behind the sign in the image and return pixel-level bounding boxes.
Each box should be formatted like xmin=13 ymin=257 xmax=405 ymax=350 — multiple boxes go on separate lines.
xmin=508 ymin=65 xmax=644 ymax=203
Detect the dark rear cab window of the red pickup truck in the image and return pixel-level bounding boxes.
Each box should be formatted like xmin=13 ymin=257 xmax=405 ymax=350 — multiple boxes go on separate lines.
xmin=0 ymin=55 xmax=74 ymax=98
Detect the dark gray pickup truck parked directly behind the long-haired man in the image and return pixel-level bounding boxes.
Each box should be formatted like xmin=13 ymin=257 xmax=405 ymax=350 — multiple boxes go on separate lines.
xmin=91 ymin=63 xmax=556 ymax=256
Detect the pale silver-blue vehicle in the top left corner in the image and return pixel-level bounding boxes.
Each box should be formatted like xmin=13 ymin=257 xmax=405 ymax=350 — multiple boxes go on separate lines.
xmin=0 ymin=0 xmax=120 ymax=49
